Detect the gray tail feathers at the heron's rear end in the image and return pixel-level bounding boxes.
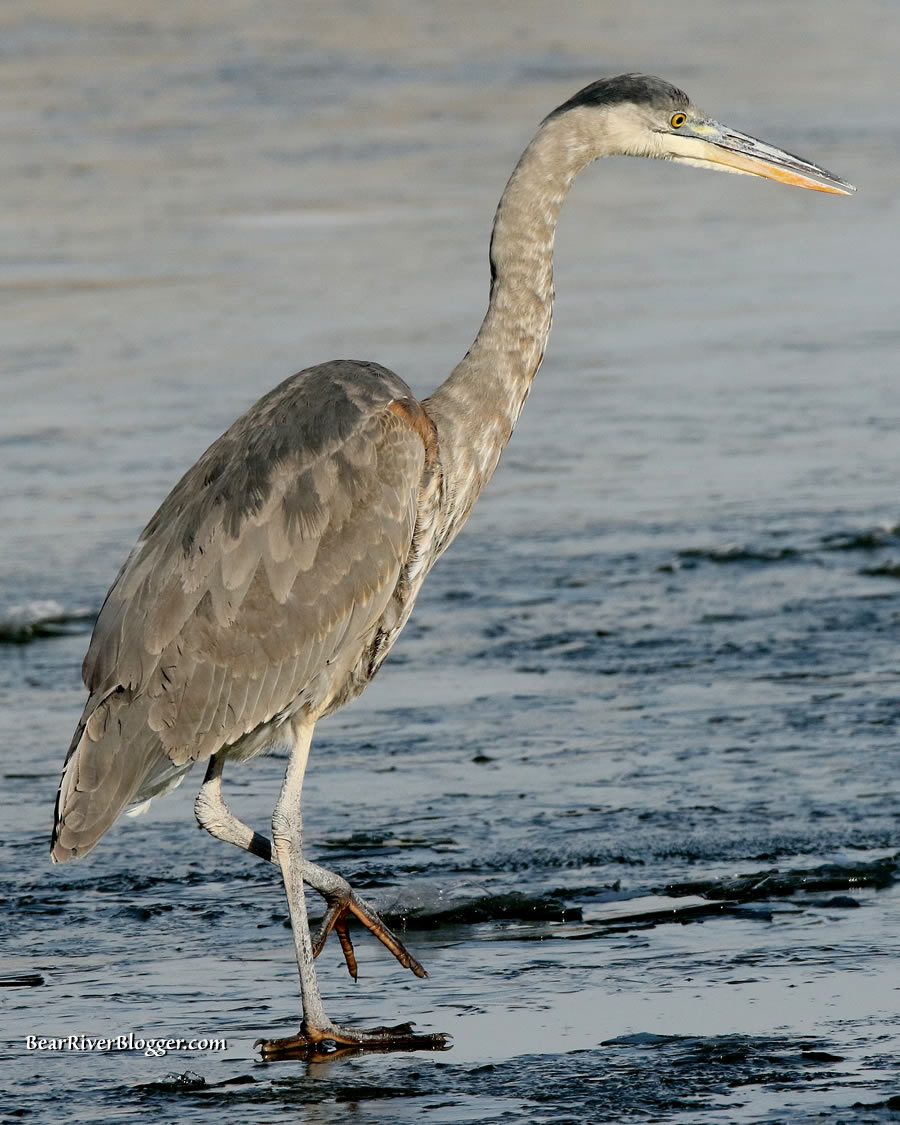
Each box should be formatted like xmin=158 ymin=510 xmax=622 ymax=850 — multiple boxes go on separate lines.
xmin=51 ymin=690 xmax=178 ymax=863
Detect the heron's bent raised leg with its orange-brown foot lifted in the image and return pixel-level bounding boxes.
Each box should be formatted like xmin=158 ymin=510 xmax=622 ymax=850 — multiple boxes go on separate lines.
xmin=194 ymin=753 xmax=428 ymax=980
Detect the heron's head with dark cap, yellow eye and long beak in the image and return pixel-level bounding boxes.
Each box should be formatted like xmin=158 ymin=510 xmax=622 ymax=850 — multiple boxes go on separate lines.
xmin=548 ymin=74 xmax=856 ymax=196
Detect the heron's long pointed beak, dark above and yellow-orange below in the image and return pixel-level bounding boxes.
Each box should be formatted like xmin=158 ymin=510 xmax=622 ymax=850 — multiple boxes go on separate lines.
xmin=666 ymin=122 xmax=856 ymax=196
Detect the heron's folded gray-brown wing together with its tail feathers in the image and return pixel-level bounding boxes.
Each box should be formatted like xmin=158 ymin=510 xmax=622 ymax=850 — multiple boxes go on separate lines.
xmin=54 ymin=361 xmax=425 ymax=858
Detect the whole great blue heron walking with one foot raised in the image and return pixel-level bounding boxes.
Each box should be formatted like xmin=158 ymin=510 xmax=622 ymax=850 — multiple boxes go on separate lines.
xmin=52 ymin=74 xmax=854 ymax=1058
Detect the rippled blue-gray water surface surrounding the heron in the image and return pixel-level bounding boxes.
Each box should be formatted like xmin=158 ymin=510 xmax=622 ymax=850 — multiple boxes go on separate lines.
xmin=0 ymin=0 xmax=900 ymax=1125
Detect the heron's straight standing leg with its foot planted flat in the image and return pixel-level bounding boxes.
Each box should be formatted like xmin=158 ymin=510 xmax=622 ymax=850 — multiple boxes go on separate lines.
xmin=257 ymin=717 xmax=447 ymax=1059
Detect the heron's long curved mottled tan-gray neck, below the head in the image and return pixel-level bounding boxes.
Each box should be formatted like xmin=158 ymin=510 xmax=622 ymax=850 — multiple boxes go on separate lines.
xmin=424 ymin=114 xmax=597 ymax=549
